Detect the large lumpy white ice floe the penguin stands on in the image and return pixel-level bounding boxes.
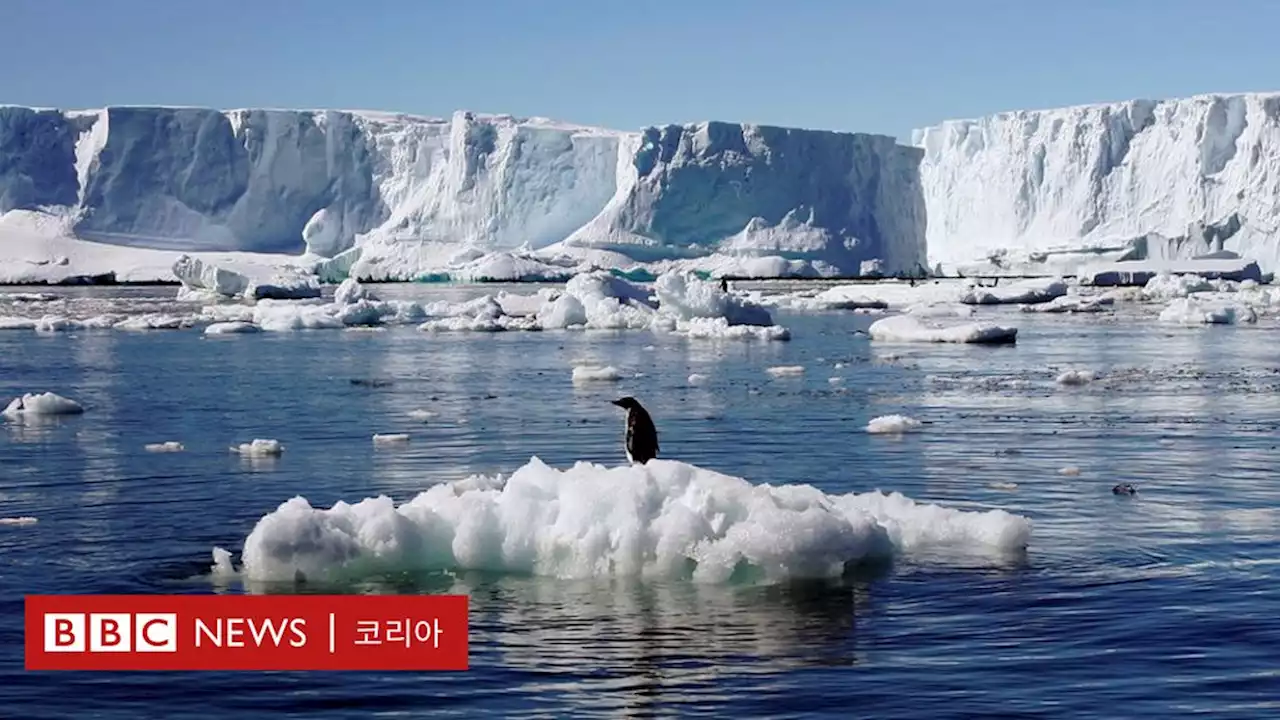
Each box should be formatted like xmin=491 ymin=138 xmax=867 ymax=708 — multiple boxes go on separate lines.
xmin=215 ymin=457 xmax=1032 ymax=583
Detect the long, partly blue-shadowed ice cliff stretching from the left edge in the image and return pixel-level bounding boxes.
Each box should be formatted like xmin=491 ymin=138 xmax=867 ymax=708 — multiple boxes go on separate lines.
xmin=0 ymin=106 xmax=924 ymax=279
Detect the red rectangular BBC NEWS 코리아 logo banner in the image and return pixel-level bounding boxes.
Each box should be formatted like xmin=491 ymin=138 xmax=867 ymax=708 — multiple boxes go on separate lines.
xmin=24 ymin=594 xmax=470 ymax=670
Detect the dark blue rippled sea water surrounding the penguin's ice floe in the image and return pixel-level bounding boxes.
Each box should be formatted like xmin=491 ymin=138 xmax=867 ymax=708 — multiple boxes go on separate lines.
xmin=0 ymin=286 xmax=1280 ymax=719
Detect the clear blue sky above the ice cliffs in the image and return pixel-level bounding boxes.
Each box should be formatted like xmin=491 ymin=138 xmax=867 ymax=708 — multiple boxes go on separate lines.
xmin=0 ymin=0 xmax=1280 ymax=141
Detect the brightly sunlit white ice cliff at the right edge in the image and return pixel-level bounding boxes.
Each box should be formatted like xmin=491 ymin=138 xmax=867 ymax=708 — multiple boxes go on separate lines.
xmin=913 ymin=94 xmax=1280 ymax=270
